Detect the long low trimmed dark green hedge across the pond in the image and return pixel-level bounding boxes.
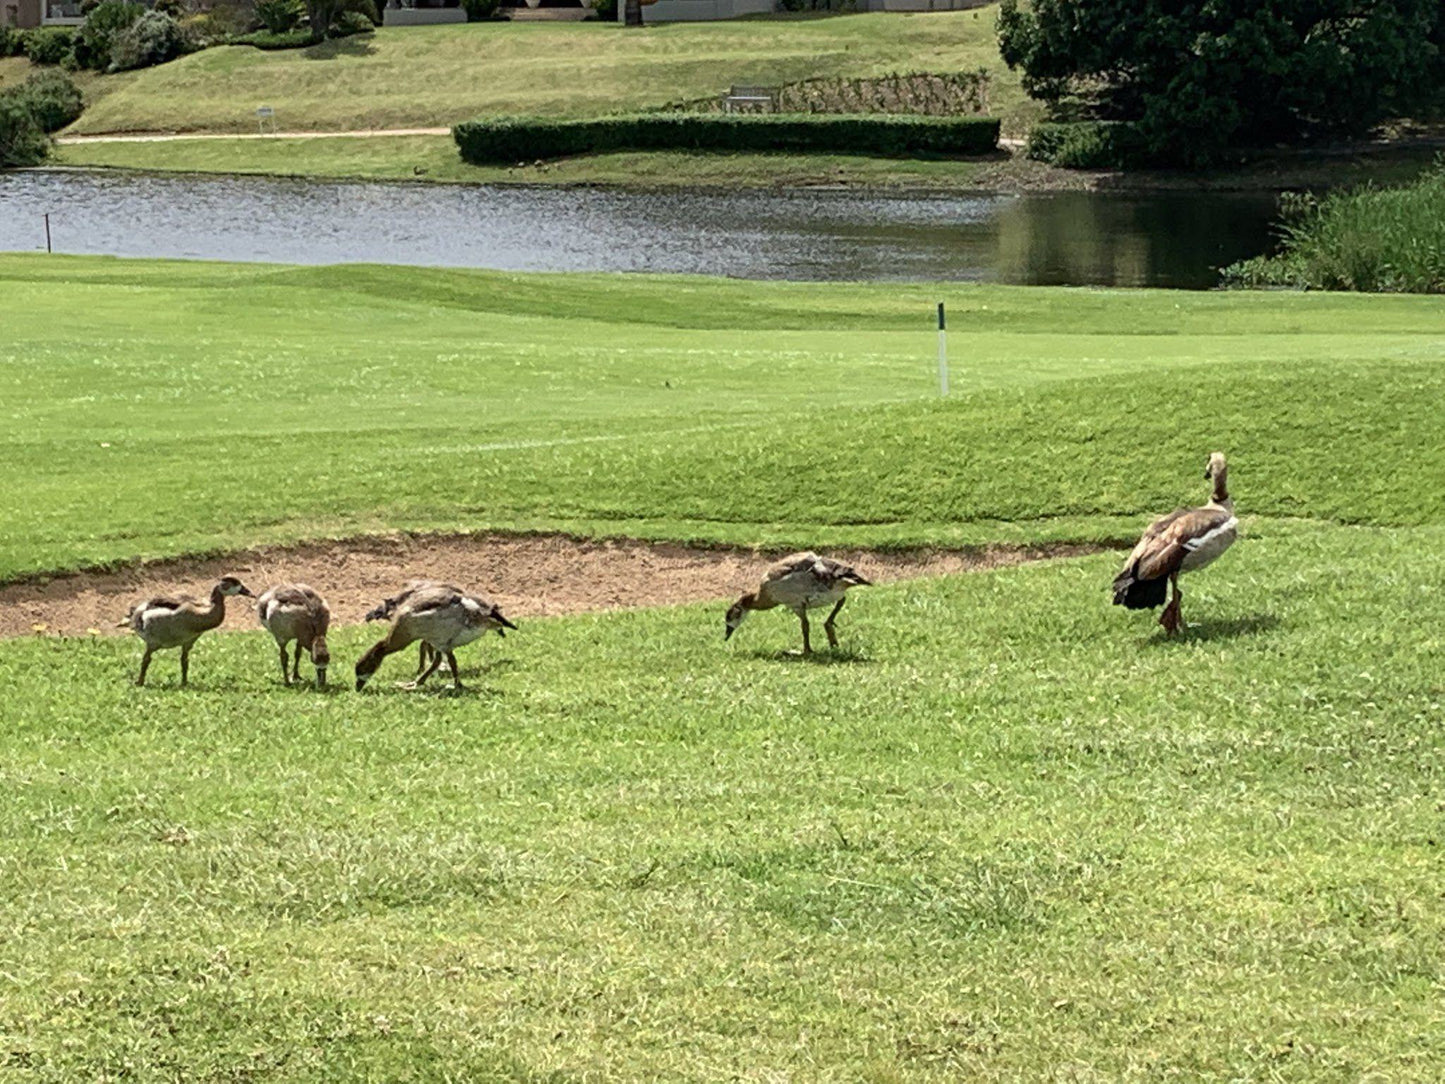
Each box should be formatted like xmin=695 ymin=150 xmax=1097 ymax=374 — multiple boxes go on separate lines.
xmin=452 ymin=113 xmax=998 ymax=165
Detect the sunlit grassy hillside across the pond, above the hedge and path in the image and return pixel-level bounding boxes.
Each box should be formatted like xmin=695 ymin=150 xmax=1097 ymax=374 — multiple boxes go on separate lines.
xmin=74 ymin=10 xmax=1023 ymax=132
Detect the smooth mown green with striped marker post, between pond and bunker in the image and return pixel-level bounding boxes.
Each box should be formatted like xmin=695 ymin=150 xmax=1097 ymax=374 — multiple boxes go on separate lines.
xmin=0 ymin=256 xmax=1445 ymax=577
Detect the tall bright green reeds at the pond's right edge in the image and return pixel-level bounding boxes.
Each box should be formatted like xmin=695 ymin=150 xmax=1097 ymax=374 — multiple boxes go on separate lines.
xmin=1224 ymin=159 xmax=1445 ymax=293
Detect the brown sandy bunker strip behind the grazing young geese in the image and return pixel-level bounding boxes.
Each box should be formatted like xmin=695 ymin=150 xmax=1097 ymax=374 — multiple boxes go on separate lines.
xmin=0 ymin=533 xmax=1107 ymax=639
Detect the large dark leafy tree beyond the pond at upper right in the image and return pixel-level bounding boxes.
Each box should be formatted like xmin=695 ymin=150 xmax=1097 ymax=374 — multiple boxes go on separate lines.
xmin=998 ymin=0 xmax=1445 ymax=165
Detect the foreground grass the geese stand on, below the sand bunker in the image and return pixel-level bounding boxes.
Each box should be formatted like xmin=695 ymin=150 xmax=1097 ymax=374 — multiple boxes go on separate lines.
xmin=0 ymin=526 xmax=1445 ymax=1081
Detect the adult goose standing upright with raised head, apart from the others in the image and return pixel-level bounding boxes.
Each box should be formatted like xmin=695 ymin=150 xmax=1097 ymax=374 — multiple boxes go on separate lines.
xmin=1114 ymin=452 xmax=1240 ymax=636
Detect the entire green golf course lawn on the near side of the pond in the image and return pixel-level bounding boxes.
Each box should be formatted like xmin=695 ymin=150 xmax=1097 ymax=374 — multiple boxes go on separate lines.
xmin=0 ymin=257 xmax=1445 ymax=1081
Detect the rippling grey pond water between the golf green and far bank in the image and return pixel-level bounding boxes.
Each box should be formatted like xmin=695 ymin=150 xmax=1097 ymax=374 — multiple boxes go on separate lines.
xmin=0 ymin=171 xmax=1274 ymax=288
